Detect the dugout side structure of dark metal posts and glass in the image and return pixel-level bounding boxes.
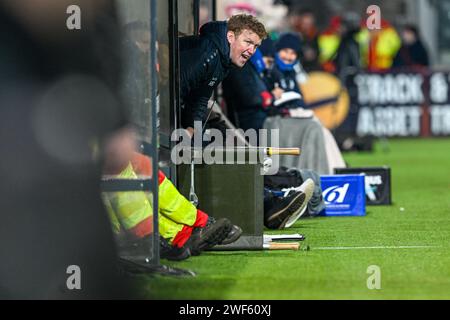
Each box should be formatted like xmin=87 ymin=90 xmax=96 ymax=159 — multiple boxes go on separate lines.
xmin=101 ymin=0 xmax=208 ymax=275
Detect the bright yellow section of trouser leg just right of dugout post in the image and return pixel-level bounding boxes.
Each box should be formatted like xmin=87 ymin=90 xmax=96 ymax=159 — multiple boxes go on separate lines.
xmin=159 ymin=178 xmax=197 ymax=226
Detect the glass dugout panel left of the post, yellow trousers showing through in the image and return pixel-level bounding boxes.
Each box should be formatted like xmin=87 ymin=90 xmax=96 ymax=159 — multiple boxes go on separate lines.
xmin=102 ymin=0 xmax=159 ymax=265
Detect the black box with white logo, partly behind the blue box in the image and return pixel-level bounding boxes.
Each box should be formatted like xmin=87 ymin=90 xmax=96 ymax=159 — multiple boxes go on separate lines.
xmin=334 ymin=167 xmax=392 ymax=206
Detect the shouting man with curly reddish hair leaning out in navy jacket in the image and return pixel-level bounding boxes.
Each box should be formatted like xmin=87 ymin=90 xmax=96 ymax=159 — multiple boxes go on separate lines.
xmin=180 ymin=14 xmax=267 ymax=136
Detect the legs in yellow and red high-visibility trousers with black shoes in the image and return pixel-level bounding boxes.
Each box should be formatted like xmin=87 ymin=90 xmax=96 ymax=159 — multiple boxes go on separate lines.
xmin=103 ymin=153 xmax=242 ymax=260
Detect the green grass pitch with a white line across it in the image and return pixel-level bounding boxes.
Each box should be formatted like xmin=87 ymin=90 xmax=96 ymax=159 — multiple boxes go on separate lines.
xmin=136 ymin=139 xmax=450 ymax=299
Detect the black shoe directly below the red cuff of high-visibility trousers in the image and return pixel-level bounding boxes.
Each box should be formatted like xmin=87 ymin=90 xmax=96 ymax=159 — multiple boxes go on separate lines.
xmin=188 ymin=216 xmax=232 ymax=256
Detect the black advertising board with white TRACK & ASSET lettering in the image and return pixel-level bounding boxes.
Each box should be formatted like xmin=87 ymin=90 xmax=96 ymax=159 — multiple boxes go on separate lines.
xmin=336 ymin=70 xmax=450 ymax=137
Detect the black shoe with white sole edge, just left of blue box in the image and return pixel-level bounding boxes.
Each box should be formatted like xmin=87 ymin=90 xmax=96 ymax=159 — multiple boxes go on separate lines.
xmin=264 ymin=191 xmax=306 ymax=229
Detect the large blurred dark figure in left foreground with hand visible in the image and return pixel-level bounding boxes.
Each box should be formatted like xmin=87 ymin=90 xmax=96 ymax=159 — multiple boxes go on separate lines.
xmin=0 ymin=0 xmax=134 ymax=299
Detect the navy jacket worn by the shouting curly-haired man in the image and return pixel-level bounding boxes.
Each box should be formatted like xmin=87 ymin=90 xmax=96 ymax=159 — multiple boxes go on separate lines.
xmin=180 ymin=21 xmax=233 ymax=128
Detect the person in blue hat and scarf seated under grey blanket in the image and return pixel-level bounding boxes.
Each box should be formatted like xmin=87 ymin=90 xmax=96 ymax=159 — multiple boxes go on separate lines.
xmin=264 ymin=33 xmax=345 ymax=174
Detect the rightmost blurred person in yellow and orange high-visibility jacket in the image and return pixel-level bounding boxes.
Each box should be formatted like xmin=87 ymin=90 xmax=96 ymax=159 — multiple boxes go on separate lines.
xmin=357 ymin=20 xmax=401 ymax=71
